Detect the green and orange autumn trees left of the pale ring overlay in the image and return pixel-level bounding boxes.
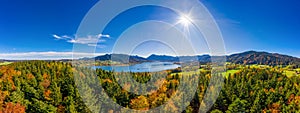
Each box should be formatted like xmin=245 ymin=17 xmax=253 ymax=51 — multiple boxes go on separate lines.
xmin=0 ymin=61 xmax=89 ymax=113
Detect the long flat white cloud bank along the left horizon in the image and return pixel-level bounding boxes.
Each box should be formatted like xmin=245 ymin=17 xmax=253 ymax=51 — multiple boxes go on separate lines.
xmin=0 ymin=51 xmax=103 ymax=60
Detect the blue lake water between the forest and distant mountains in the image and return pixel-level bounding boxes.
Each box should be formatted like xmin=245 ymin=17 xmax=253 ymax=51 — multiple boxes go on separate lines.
xmin=94 ymin=62 xmax=180 ymax=72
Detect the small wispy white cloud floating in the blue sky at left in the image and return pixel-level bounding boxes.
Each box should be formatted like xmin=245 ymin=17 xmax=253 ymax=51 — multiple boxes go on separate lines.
xmin=52 ymin=34 xmax=111 ymax=47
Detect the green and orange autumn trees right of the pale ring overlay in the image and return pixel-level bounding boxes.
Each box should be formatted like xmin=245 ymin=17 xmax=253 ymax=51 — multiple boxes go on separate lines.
xmin=212 ymin=67 xmax=300 ymax=113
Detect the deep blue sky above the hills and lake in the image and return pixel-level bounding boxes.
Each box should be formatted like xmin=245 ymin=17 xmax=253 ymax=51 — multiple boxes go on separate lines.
xmin=0 ymin=0 xmax=300 ymax=59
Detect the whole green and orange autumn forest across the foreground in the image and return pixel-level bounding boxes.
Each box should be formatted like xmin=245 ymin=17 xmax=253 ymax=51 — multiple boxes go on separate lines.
xmin=0 ymin=61 xmax=300 ymax=113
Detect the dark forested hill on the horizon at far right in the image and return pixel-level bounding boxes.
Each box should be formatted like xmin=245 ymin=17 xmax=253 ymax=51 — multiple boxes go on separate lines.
xmin=227 ymin=51 xmax=300 ymax=65
